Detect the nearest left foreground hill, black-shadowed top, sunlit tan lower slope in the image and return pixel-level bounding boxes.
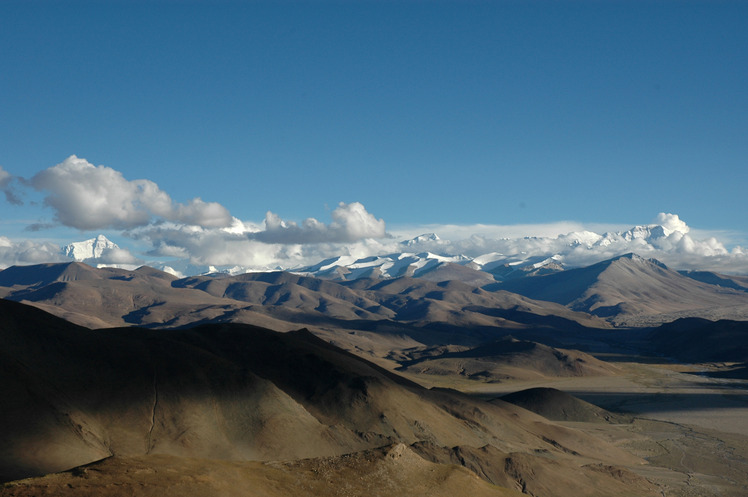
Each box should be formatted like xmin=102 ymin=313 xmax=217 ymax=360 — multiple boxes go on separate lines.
xmin=0 ymin=301 xmax=361 ymax=479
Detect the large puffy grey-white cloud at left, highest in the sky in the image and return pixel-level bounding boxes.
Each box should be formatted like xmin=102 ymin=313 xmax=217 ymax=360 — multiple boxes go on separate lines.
xmin=31 ymin=155 xmax=232 ymax=230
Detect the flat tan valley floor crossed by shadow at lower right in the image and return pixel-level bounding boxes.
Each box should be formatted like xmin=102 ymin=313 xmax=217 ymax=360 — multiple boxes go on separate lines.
xmin=420 ymin=357 xmax=748 ymax=497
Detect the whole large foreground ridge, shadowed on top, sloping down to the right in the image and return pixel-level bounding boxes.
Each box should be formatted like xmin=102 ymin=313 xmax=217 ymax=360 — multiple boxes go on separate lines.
xmin=0 ymin=300 xmax=641 ymax=495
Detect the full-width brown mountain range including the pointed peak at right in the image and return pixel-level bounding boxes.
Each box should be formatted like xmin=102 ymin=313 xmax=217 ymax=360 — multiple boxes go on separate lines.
xmin=0 ymin=254 xmax=748 ymax=336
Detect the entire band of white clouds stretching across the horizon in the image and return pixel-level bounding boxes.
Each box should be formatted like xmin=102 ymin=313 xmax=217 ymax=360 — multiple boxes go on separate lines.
xmin=0 ymin=155 xmax=748 ymax=274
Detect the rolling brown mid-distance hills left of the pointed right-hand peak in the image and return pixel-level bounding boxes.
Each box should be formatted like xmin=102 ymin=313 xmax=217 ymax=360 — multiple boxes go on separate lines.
xmin=0 ymin=263 xmax=607 ymax=343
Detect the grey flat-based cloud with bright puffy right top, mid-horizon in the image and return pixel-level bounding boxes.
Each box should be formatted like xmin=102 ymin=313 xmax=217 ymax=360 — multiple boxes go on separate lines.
xmin=254 ymin=202 xmax=387 ymax=244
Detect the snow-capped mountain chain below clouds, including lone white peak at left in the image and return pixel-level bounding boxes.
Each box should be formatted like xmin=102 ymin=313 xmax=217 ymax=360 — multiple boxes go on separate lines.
xmin=57 ymin=215 xmax=712 ymax=285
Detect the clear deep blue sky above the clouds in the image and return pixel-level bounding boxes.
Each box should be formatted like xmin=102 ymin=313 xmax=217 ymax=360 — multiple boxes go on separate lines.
xmin=0 ymin=0 xmax=748 ymax=272
